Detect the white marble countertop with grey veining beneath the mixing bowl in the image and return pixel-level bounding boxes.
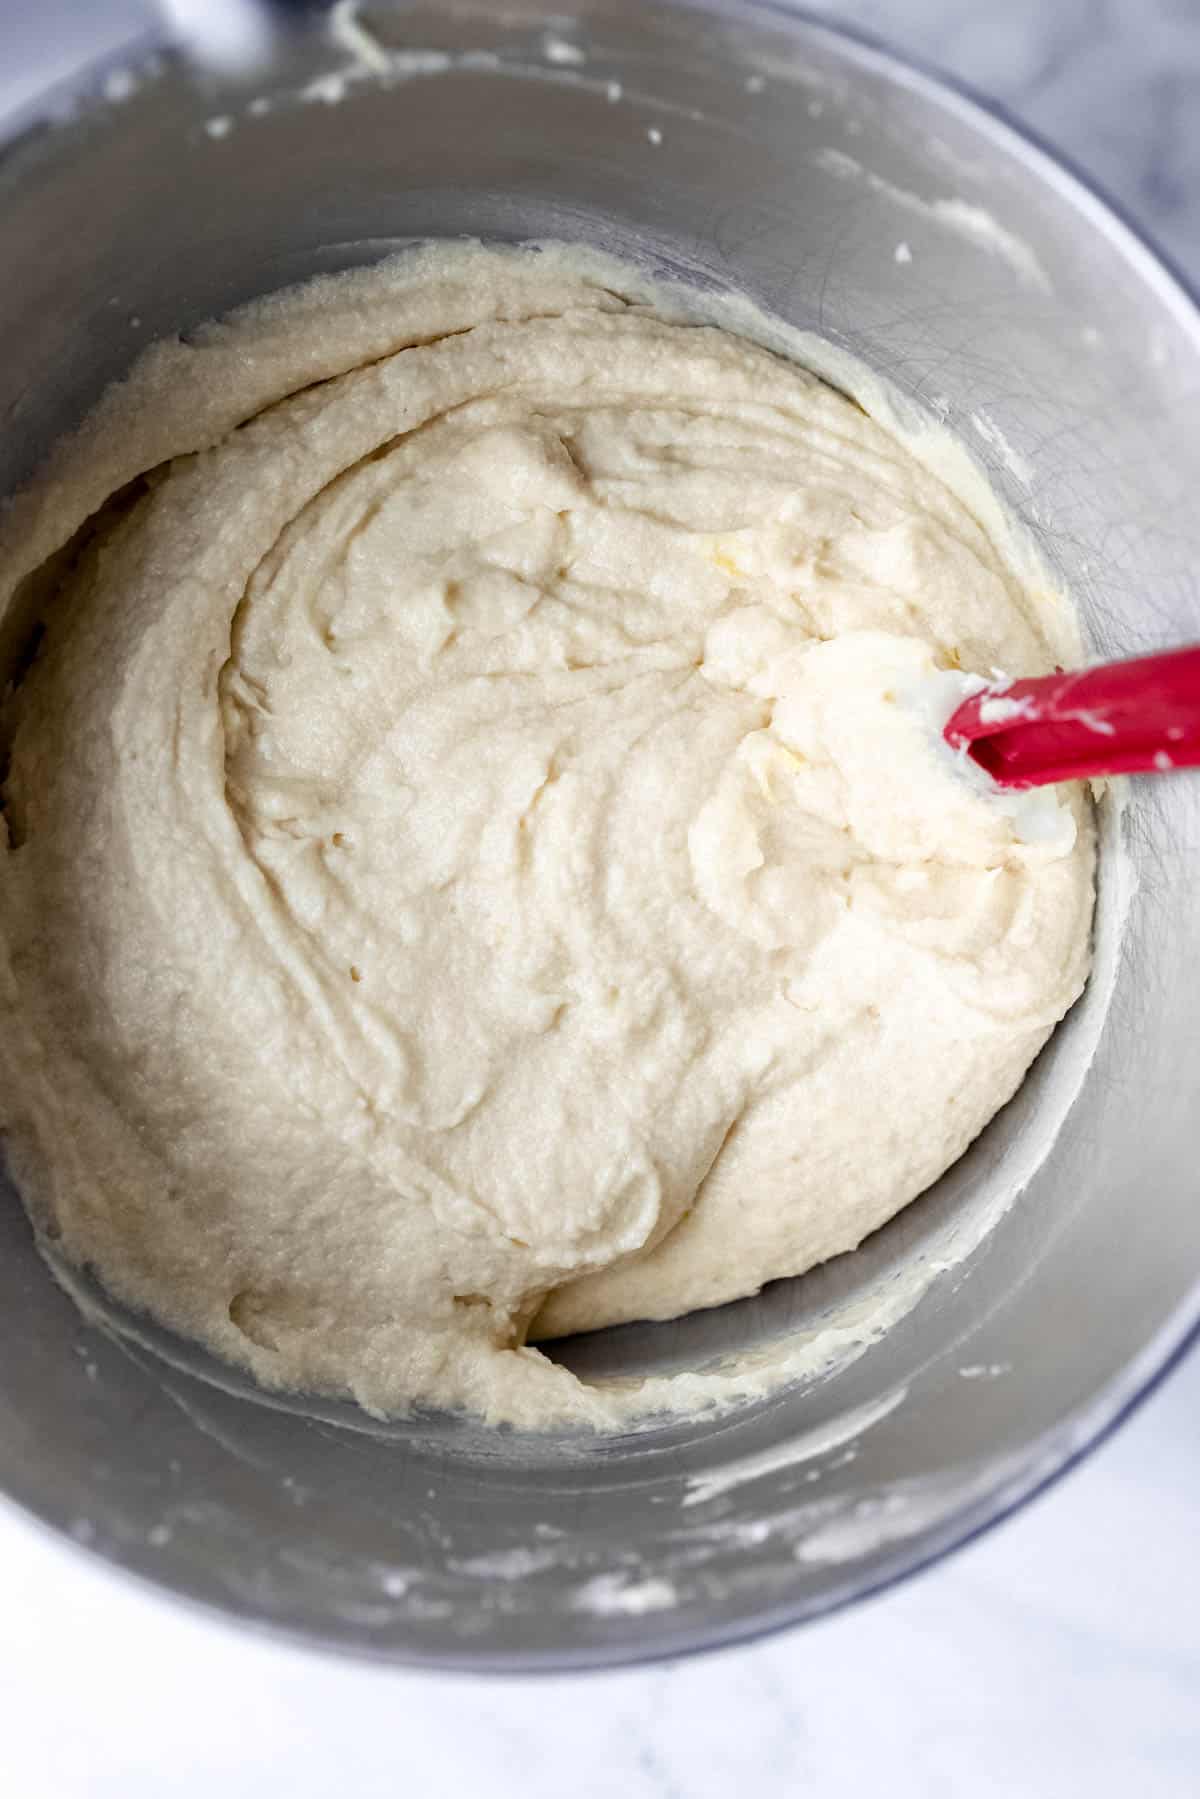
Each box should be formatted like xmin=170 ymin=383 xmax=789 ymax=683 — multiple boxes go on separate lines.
xmin=0 ymin=0 xmax=1200 ymax=1799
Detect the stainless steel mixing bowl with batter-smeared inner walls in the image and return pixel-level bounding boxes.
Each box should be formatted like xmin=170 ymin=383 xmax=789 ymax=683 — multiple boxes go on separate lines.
xmin=0 ymin=0 xmax=1200 ymax=1669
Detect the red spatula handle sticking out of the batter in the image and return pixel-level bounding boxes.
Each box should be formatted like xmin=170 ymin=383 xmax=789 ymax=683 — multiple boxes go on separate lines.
xmin=945 ymin=644 xmax=1200 ymax=788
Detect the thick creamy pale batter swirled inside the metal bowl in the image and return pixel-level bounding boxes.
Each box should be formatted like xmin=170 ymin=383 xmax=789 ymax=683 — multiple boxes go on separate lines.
xmin=0 ymin=246 xmax=1092 ymax=1425
